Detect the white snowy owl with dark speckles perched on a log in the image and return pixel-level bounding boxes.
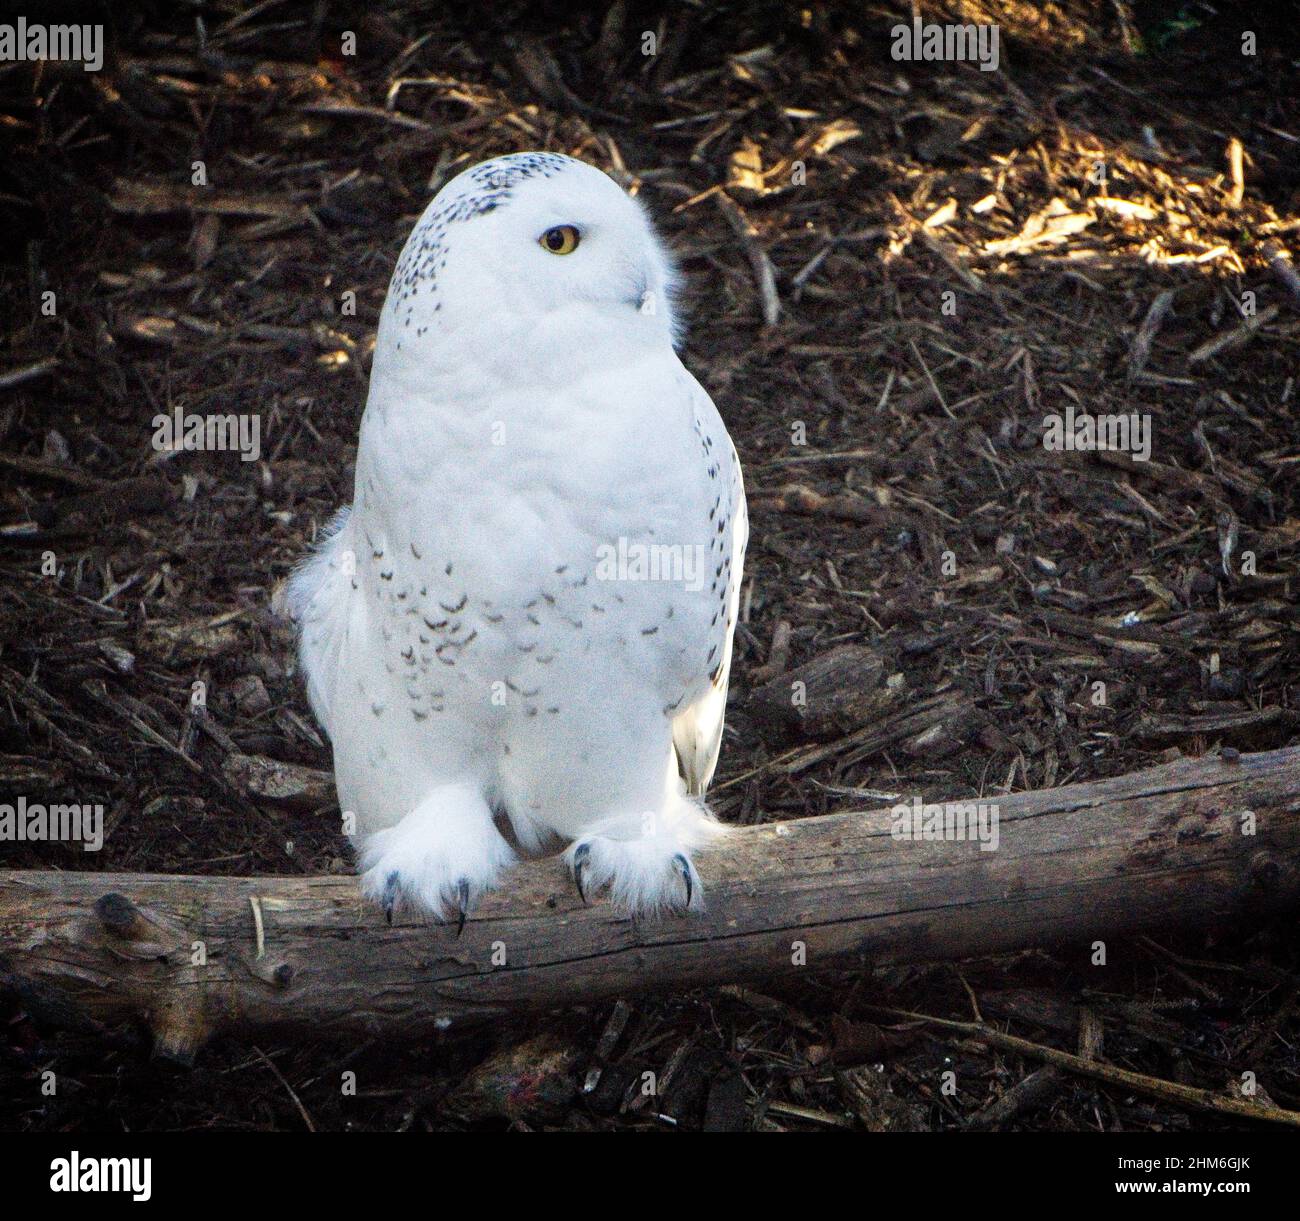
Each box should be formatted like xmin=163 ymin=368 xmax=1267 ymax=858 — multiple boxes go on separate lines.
xmin=290 ymin=152 xmax=749 ymax=927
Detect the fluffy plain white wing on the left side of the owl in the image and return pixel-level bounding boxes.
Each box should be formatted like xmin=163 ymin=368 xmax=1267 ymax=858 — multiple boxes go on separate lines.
xmin=289 ymin=507 xmax=356 ymax=737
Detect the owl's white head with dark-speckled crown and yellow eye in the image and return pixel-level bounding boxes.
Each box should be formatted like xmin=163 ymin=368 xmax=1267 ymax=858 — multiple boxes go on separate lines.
xmin=381 ymin=152 xmax=676 ymax=350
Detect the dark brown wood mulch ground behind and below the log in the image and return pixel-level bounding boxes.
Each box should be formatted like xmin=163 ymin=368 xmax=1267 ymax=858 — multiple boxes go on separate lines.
xmin=0 ymin=0 xmax=1300 ymax=1130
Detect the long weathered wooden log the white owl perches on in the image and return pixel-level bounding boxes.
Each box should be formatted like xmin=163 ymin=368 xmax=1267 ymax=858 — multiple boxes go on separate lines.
xmin=0 ymin=746 xmax=1300 ymax=1061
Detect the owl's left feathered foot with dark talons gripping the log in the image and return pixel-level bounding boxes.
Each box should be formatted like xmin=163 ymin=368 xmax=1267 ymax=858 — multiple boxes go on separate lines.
xmin=361 ymin=783 xmax=516 ymax=928
